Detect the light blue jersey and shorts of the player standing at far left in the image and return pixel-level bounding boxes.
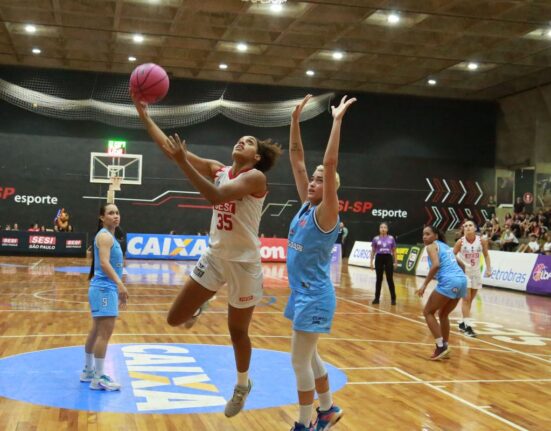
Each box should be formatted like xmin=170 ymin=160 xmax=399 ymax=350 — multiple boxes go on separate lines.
xmin=88 ymin=229 xmax=123 ymax=317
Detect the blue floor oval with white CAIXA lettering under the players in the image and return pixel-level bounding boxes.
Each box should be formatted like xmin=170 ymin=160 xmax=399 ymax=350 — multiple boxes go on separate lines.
xmin=0 ymin=344 xmax=346 ymax=414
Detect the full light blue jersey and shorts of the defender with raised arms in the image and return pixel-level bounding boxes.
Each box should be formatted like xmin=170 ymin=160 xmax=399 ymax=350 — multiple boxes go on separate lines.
xmin=284 ymin=202 xmax=339 ymax=333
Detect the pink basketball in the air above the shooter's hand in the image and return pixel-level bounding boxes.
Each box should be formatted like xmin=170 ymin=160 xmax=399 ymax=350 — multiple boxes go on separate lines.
xmin=130 ymin=63 xmax=170 ymax=103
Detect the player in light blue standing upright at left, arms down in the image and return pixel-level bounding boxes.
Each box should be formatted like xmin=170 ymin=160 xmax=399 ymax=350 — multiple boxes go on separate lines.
xmin=80 ymin=203 xmax=128 ymax=391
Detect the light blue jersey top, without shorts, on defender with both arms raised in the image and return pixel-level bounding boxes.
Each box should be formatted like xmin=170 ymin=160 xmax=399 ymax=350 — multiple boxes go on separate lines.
xmin=287 ymin=202 xmax=339 ymax=295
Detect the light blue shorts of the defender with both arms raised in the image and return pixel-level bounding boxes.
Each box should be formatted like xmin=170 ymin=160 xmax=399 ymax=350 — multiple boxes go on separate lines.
xmin=284 ymin=291 xmax=337 ymax=333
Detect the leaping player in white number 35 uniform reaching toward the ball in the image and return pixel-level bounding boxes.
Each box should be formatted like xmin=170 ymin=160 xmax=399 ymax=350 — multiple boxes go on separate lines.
xmin=134 ymin=94 xmax=281 ymax=417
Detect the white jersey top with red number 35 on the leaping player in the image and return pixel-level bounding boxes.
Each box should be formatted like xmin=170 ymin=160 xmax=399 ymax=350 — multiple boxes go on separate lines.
xmin=209 ymin=166 xmax=266 ymax=262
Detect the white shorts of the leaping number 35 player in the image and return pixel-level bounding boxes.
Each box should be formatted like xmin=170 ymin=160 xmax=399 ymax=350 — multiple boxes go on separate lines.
xmin=190 ymin=249 xmax=263 ymax=308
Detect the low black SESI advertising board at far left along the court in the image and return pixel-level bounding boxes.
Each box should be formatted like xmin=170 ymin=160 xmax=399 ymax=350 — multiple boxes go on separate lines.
xmin=0 ymin=230 xmax=88 ymax=257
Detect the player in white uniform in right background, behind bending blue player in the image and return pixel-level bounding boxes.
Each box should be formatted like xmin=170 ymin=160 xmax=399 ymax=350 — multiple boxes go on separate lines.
xmin=453 ymin=220 xmax=492 ymax=337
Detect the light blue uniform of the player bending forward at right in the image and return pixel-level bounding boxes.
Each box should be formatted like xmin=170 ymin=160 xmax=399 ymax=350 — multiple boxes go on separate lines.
xmin=428 ymin=240 xmax=467 ymax=299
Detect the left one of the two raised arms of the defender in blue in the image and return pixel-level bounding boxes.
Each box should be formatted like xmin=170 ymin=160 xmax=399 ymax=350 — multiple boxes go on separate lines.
xmin=289 ymin=94 xmax=312 ymax=202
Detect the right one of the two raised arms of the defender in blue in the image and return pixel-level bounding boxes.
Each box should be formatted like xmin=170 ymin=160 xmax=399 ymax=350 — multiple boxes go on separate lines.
xmin=316 ymin=96 xmax=356 ymax=230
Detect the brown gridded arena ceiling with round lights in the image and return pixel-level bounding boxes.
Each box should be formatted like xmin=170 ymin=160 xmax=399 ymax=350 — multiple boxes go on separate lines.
xmin=0 ymin=0 xmax=551 ymax=100
